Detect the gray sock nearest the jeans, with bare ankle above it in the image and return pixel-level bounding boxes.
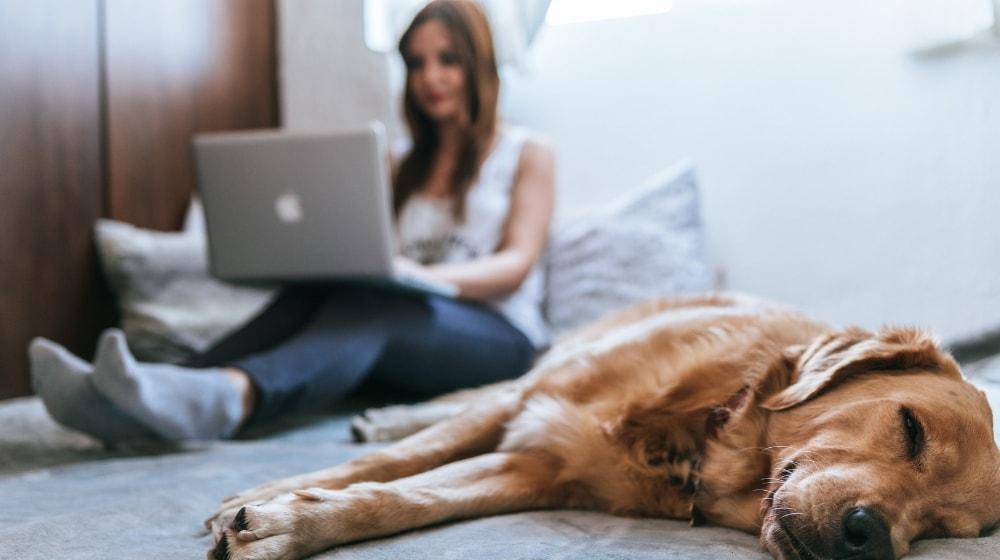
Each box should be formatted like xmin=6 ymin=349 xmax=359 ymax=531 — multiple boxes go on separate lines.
xmin=94 ymin=329 xmax=243 ymax=440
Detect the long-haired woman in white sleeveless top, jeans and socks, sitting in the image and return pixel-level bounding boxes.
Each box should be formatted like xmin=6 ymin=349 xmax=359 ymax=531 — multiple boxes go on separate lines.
xmin=30 ymin=0 xmax=554 ymax=441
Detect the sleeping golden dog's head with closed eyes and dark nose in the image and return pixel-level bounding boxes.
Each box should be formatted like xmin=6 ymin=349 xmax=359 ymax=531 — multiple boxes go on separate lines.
xmin=761 ymin=329 xmax=1000 ymax=559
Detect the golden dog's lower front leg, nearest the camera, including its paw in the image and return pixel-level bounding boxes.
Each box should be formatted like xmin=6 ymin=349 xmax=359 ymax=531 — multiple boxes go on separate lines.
xmin=209 ymin=453 xmax=565 ymax=560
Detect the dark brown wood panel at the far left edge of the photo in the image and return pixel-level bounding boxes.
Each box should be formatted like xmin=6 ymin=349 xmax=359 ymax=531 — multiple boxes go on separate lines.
xmin=0 ymin=0 xmax=109 ymax=398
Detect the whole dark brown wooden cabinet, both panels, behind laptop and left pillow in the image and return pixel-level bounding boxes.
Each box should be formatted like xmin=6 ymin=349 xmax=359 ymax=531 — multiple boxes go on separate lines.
xmin=0 ymin=0 xmax=278 ymax=398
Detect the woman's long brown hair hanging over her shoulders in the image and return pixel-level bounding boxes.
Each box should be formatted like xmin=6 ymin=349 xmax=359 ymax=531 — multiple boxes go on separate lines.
xmin=393 ymin=0 xmax=500 ymax=221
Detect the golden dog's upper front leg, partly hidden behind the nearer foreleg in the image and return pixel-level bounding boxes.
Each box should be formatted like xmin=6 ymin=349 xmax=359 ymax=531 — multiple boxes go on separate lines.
xmin=205 ymin=387 xmax=521 ymax=539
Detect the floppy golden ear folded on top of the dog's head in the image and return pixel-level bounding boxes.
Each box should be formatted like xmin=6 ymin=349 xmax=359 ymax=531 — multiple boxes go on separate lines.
xmin=763 ymin=328 xmax=962 ymax=410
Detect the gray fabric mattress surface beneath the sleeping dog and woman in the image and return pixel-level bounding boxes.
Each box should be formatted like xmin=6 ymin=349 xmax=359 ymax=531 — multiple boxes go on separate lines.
xmin=0 ymin=354 xmax=1000 ymax=560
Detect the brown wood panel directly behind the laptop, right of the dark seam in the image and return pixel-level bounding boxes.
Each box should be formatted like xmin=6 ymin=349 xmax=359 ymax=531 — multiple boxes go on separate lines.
xmin=105 ymin=0 xmax=278 ymax=230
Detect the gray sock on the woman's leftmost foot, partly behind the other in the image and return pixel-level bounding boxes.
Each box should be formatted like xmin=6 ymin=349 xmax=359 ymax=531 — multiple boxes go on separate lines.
xmin=28 ymin=338 xmax=156 ymax=443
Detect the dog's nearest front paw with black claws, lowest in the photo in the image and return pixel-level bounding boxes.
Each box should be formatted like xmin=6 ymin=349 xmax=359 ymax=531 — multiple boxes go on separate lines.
xmin=208 ymin=489 xmax=340 ymax=560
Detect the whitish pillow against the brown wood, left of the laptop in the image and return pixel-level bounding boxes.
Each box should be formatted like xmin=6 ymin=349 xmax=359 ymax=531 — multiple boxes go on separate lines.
xmin=94 ymin=200 xmax=273 ymax=362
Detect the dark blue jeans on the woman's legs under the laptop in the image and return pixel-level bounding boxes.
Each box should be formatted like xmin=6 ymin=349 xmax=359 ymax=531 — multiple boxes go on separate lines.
xmin=186 ymin=286 xmax=535 ymax=424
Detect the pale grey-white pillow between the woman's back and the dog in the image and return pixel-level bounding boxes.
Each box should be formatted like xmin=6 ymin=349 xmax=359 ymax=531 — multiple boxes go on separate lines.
xmin=545 ymin=161 xmax=714 ymax=334
